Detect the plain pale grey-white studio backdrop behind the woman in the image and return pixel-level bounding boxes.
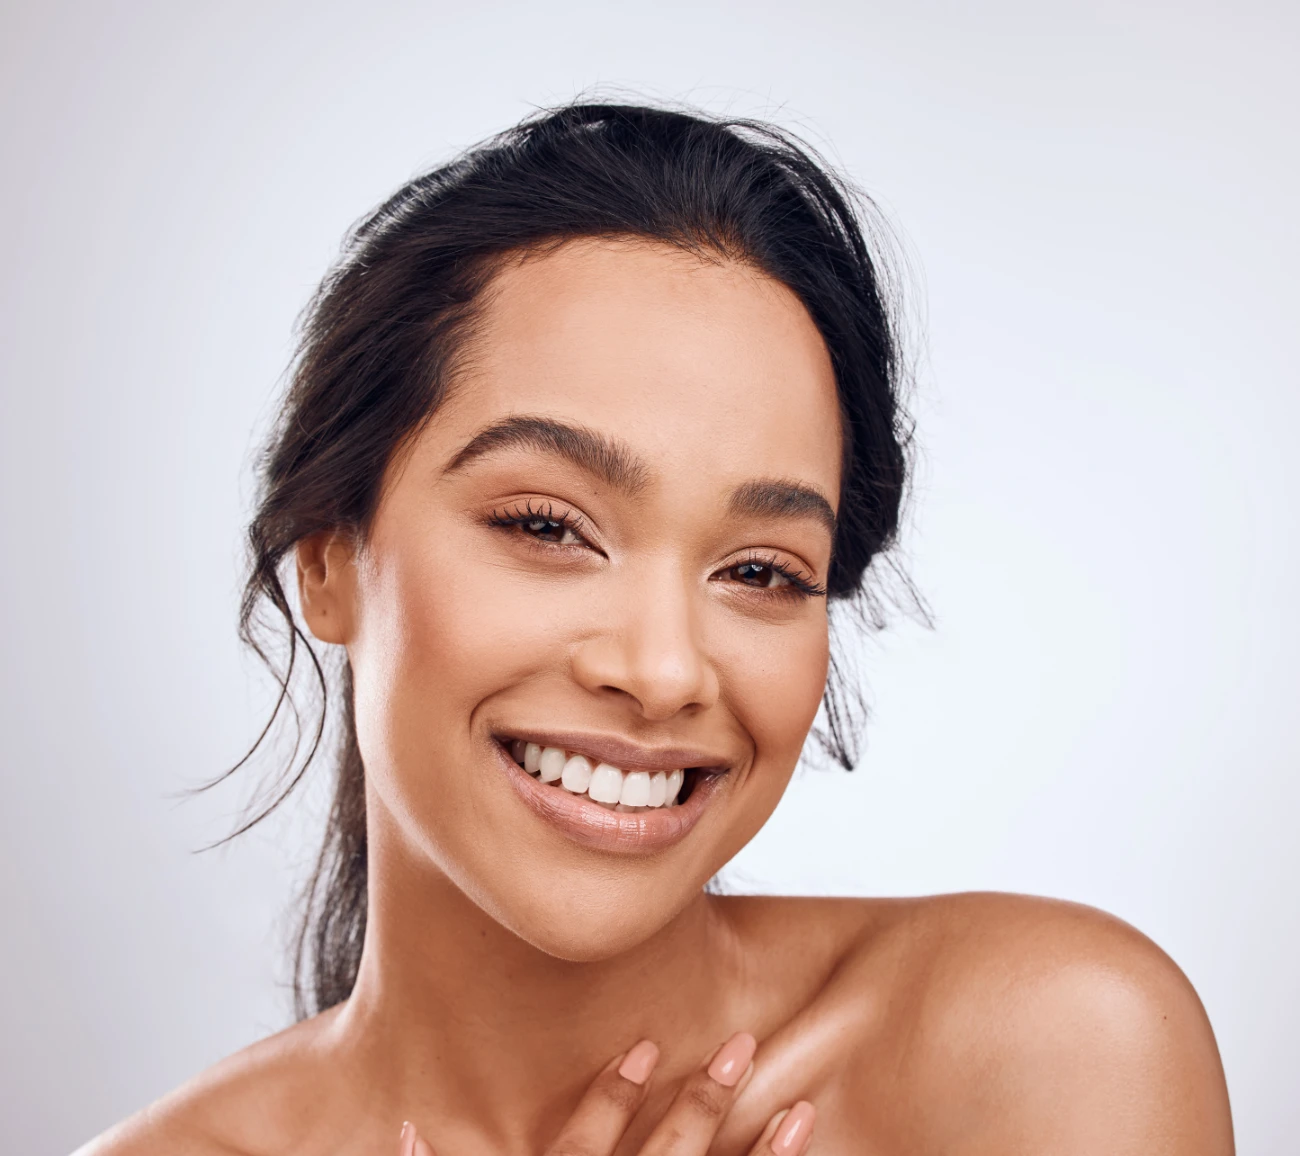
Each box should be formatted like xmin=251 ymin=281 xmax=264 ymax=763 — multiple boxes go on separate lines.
xmin=0 ymin=0 xmax=1300 ymax=1153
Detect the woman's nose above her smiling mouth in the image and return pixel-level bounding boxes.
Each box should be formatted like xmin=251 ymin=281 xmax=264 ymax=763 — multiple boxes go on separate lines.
xmin=572 ymin=561 xmax=719 ymax=722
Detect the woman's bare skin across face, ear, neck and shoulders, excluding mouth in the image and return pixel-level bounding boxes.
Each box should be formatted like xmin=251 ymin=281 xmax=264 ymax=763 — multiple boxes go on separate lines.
xmin=83 ymin=241 xmax=1232 ymax=1156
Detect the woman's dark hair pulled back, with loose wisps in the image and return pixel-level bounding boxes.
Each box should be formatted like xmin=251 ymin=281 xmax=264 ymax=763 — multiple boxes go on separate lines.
xmin=228 ymin=104 xmax=910 ymax=1017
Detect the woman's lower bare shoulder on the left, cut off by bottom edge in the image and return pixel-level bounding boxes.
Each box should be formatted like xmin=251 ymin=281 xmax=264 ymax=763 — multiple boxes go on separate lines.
xmin=73 ymin=1010 xmax=335 ymax=1156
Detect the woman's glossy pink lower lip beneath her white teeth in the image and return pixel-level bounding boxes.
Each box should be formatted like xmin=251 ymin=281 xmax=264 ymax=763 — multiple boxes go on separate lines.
xmin=493 ymin=742 xmax=727 ymax=854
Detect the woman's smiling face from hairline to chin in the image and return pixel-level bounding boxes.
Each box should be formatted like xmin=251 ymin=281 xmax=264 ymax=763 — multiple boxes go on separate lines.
xmin=315 ymin=241 xmax=841 ymax=960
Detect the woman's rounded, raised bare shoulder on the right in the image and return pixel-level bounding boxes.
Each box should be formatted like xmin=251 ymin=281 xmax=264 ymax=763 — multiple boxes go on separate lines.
xmin=841 ymin=893 xmax=1232 ymax=1156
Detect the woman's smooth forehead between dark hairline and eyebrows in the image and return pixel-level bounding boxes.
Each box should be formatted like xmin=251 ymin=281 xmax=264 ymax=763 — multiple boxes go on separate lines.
xmin=433 ymin=241 xmax=840 ymax=502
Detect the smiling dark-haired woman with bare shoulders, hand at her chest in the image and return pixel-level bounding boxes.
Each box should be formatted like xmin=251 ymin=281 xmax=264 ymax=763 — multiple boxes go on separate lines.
xmin=78 ymin=105 xmax=1232 ymax=1156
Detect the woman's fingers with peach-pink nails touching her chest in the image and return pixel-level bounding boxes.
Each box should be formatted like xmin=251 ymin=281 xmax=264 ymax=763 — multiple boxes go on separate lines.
xmin=399 ymin=1031 xmax=815 ymax=1156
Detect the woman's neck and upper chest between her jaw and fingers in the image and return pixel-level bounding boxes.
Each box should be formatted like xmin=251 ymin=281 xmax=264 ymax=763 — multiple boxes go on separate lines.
xmin=330 ymin=795 xmax=745 ymax=1151
